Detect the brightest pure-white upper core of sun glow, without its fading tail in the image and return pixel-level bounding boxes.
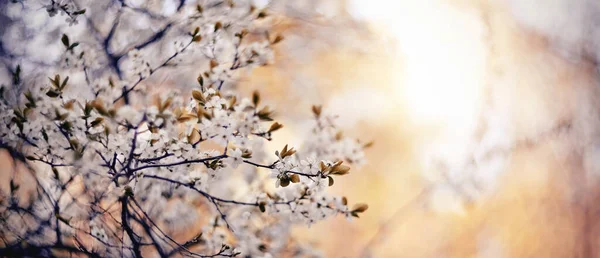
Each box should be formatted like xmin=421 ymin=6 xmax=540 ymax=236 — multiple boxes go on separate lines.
xmin=351 ymin=0 xmax=486 ymax=130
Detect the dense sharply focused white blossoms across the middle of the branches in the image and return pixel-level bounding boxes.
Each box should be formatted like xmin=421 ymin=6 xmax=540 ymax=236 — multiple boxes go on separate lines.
xmin=0 ymin=80 xmax=366 ymax=253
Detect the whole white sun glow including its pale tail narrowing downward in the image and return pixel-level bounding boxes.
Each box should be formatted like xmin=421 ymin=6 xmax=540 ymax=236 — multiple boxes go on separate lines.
xmin=351 ymin=0 xmax=494 ymax=214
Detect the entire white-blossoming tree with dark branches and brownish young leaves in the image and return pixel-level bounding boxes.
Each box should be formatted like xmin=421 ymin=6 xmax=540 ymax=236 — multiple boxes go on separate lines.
xmin=0 ymin=1 xmax=368 ymax=257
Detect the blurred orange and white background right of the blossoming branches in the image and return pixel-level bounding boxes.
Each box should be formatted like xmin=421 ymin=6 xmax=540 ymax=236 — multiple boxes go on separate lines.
xmin=5 ymin=0 xmax=600 ymax=258
